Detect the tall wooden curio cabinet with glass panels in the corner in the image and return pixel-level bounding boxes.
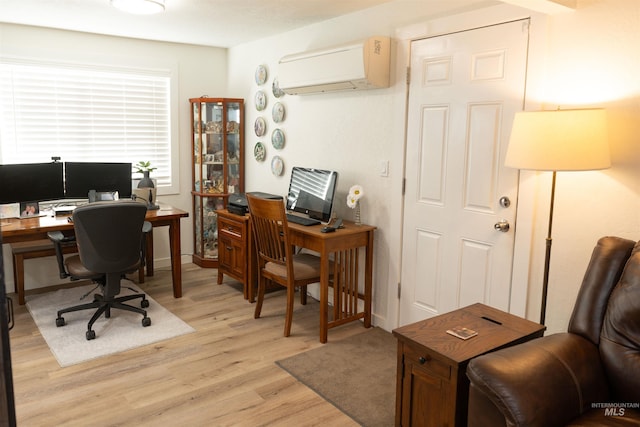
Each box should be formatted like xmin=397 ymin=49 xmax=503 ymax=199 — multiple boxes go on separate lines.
xmin=189 ymin=97 xmax=244 ymax=267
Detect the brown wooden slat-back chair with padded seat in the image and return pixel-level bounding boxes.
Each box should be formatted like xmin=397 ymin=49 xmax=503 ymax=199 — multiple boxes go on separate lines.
xmin=247 ymin=194 xmax=320 ymax=337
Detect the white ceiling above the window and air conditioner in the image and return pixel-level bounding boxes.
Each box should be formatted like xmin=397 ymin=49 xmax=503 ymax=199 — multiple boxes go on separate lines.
xmin=0 ymin=0 xmax=498 ymax=47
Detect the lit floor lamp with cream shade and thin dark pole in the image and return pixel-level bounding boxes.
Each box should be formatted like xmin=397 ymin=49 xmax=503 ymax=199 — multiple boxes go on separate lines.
xmin=505 ymin=109 xmax=611 ymax=325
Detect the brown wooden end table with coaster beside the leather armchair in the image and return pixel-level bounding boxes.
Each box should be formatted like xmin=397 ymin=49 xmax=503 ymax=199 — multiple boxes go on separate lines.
xmin=393 ymin=303 xmax=545 ymax=427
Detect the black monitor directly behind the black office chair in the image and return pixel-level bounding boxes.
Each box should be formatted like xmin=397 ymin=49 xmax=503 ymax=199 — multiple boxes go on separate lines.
xmin=64 ymin=162 xmax=133 ymax=199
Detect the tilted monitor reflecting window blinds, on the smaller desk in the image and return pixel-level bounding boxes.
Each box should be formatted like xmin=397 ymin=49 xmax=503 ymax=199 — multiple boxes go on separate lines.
xmin=287 ymin=166 xmax=338 ymax=223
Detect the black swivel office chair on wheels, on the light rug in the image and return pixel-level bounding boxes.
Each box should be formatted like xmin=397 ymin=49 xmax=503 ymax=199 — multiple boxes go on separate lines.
xmin=50 ymin=201 xmax=151 ymax=340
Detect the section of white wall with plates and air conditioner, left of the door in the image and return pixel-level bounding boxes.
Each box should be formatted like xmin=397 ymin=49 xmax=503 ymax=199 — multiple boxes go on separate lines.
xmin=229 ymin=5 xmax=424 ymax=329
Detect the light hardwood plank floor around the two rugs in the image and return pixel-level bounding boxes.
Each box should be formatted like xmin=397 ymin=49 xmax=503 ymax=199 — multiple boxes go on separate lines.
xmin=10 ymin=264 xmax=363 ymax=426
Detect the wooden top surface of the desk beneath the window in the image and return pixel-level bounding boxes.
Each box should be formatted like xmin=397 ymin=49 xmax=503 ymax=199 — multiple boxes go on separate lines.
xmin=0 ymin=205 xmax=189 ymax=243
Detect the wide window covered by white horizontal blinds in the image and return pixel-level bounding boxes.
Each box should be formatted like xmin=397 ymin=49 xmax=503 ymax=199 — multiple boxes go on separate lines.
xmin=0 ymin=62 xmax=175 ymax=187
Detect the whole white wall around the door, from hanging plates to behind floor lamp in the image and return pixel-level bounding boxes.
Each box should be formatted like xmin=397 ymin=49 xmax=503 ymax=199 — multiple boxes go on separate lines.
xmin=229 ymin=0 xmax=640 ymax=332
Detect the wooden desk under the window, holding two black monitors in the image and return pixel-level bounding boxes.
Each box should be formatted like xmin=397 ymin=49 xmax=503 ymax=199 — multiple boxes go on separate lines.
xmin=0 ymin=205 xmax=189 ymax=298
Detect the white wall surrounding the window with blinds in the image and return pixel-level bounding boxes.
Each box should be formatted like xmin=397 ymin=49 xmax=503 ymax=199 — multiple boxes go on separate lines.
xmin=0 ymin=24 xmax=227 ymax=292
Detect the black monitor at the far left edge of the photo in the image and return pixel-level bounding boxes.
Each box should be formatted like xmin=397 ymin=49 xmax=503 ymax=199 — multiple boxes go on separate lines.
xmin=0 ymin=163 xmax=64 ymax=204
